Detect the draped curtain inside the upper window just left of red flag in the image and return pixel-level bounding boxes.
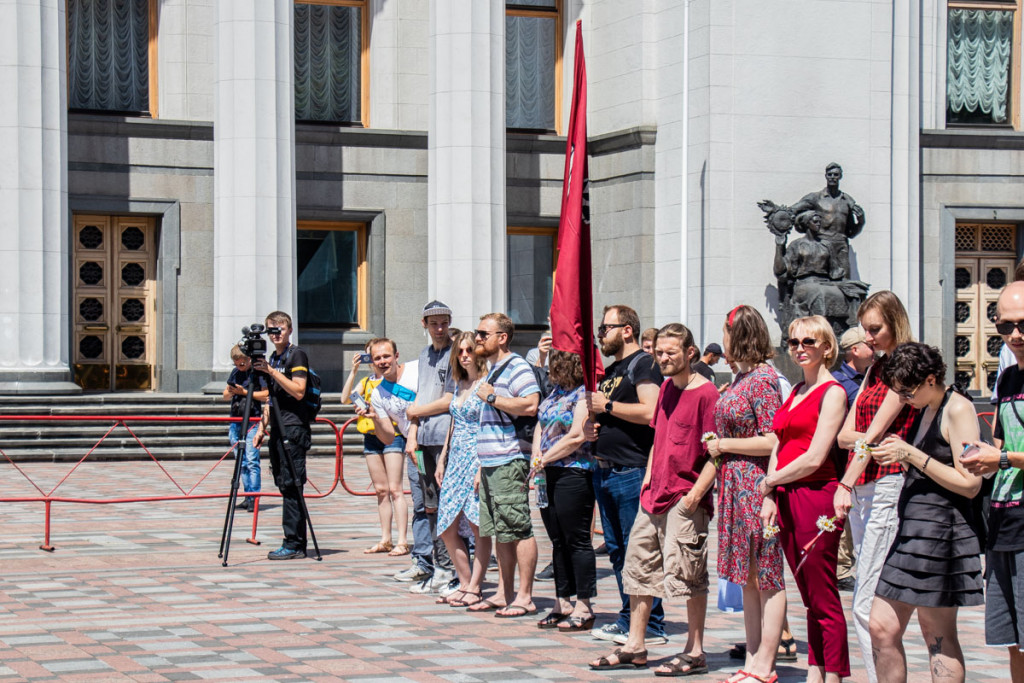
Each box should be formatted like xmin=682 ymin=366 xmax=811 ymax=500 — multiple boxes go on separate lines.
xmin=505 ymin=16 xmax=555 ymax=130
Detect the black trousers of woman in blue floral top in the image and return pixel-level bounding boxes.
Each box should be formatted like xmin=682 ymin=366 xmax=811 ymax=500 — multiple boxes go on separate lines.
xmin=541 ymin=467 xmax=597 ymax=600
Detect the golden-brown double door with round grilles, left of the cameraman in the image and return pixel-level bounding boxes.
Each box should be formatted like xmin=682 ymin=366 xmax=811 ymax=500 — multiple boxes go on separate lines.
xmin=72 ymin=215 xmax=157 ymax=391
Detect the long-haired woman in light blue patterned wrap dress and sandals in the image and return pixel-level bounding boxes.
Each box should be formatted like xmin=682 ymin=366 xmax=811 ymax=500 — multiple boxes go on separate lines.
xmin=436 ymin=332 xmax=490 ymax=607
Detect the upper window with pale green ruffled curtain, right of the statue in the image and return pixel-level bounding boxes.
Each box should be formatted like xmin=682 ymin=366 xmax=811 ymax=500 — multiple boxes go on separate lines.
xmin=946 ymin=0 xmax=1019 ymax=125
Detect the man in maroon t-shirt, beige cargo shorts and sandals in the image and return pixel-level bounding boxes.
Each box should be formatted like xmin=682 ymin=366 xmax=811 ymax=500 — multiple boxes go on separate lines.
xmin=590 ymin=323 xmax=718 ymax=675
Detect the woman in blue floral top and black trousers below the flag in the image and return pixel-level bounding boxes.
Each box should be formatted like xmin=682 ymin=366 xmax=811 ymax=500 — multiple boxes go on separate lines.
xmin=532 ymin=350 xmax=597 ymax=632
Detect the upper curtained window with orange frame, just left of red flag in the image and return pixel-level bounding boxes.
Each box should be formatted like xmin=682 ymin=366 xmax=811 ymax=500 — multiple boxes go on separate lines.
xmin=505 ymin=0 xmax=561 ymax=131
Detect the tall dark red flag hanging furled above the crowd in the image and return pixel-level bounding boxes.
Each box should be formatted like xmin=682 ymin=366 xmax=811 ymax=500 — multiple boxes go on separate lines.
xmin=551 ymin=20 xmax=604 ymax=391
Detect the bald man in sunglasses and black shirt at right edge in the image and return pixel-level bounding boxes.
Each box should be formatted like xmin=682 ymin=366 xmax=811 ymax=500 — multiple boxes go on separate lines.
xmin=961 ymin=282 xmax=1024 ymax=682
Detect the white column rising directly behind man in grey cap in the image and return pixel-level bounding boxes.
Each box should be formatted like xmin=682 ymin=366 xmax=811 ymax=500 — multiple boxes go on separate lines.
xmin=427 ymin=0 xmax=508 ymax=329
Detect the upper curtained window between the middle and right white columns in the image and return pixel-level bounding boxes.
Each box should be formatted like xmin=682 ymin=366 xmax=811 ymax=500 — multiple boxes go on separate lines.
xmin=295 ymin=0 xmax=366 ymax=123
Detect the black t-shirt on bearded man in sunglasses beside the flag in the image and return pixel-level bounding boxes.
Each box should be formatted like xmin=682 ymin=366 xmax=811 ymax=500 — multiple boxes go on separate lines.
xmin=597 ymin=351 xmax=663 ymax=467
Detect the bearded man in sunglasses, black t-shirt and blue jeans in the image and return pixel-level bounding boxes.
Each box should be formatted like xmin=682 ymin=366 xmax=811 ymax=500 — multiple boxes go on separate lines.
xmin=587 ymin=305 xmax=669 ymax=645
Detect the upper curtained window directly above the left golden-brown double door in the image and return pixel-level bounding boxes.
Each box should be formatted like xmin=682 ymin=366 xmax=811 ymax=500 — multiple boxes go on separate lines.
xmin=68 ymin=0 xmax=156 ymax=114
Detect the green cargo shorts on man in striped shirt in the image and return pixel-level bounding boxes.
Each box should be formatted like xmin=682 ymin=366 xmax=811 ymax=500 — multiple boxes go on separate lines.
xmin=480 ymin=459 xmax=534 ymax=543
